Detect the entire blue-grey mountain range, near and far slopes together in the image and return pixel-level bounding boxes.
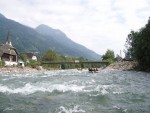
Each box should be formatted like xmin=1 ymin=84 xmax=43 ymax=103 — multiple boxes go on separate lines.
xmin=0 ymin=14 xmax=100 ymax=60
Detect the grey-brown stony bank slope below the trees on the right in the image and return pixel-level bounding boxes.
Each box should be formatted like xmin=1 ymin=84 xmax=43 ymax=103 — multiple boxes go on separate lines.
xmin=106 ymin=61 xmax=137 ymax=71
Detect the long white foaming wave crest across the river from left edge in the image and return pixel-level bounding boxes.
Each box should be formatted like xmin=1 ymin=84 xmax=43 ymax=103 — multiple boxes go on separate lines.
xmin=0 ymin=80 xmax=121 ymax=95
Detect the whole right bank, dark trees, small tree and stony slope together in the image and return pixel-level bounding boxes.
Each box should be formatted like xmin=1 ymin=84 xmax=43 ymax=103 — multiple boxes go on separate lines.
xmin=102 ymin=18 xmax=150 ymax=71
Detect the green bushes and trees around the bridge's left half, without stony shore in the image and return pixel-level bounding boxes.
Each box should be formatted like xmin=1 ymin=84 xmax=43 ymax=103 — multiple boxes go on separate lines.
xmin=20 ymin=49 xmax=88 ymax=70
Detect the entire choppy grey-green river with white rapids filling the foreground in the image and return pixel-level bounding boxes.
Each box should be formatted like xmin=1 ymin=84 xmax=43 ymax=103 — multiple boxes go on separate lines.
xmin=0 ymin=70 xmax=150 ymax=113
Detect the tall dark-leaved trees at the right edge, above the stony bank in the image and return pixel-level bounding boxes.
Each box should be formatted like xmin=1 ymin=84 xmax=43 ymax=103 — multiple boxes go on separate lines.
xmin=125 ymin=18 xmax=150 ymax=71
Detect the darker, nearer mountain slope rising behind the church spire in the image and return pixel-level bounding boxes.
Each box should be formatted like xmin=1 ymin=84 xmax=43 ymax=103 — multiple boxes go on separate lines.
xmin=0 ymin=13 xmax=48 ymax=53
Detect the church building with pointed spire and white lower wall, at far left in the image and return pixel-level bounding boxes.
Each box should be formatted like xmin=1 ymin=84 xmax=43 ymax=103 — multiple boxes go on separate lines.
xmin=0 ymin=32 xmax=18 ymax=66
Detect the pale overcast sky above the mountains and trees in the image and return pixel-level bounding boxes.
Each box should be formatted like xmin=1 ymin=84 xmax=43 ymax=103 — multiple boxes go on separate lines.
xmin=0 ymin=0 xmax=150 ymax=55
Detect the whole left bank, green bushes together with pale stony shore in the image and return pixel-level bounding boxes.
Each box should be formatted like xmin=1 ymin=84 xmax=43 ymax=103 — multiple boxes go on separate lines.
xmin=0 ymin=50 xmax=88 ymax=73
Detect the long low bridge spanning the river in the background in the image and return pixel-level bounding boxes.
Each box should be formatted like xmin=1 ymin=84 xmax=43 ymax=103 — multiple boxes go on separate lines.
xmin=42 ymin=60 xmax=108 ymax=69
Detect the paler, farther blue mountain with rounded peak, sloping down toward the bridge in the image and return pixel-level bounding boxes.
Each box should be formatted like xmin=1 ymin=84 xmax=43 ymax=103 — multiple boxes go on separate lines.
xmin=36 ymin=25 xmax=100 ymax=60
